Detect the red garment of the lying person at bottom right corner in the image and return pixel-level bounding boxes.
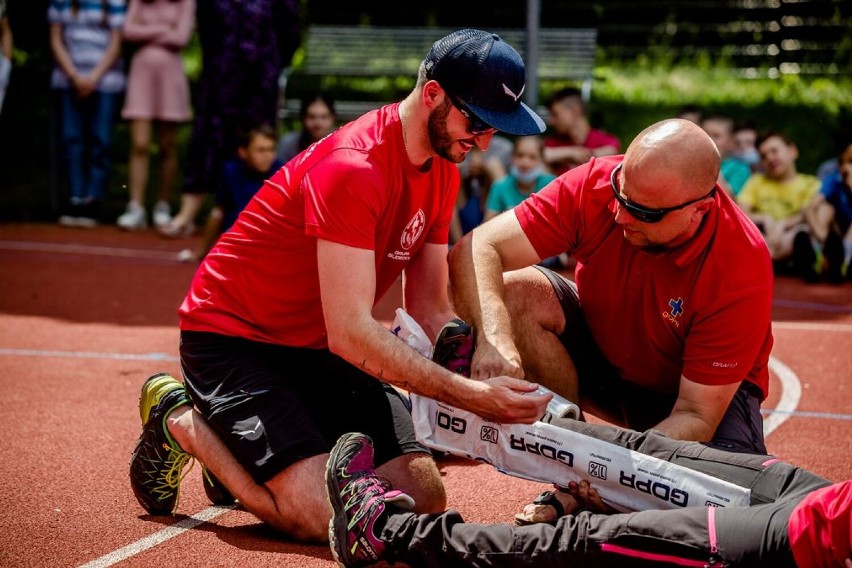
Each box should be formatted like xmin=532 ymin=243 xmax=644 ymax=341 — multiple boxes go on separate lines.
xmin=787 ymin=480 xmax=852 ymax=568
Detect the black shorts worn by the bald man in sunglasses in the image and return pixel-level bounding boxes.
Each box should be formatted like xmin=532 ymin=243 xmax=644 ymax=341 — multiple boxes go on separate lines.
xmin=536 ymin=266 xmax=766 ymax=454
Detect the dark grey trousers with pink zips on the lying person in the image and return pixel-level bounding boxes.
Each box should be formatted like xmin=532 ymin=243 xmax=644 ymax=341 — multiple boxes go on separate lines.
xmin=381 ymin=420 xmax=830 ymax=568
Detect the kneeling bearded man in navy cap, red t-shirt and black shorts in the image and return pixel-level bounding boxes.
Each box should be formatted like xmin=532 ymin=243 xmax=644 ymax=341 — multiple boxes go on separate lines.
xmin=130 ymin=30 xmax=550 ymax=541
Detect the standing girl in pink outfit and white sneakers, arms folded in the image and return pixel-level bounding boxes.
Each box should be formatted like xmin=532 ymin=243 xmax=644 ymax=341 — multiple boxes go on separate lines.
xmin=118 ymin=0 xmax=195 ymax=230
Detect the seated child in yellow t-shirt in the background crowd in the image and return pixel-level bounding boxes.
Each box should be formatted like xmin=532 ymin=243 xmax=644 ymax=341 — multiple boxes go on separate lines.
xmin=737 ymin=132 xmax=819 ymax=281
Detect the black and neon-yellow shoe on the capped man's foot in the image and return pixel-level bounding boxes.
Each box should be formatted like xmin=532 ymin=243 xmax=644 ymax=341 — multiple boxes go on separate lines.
xmin=130 ymin=373 xmax=195 ymax=515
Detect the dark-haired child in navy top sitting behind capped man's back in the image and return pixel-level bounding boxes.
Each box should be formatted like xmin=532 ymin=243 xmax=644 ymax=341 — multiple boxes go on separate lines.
xmin=178 ymin=124 xmax=284 ymax=262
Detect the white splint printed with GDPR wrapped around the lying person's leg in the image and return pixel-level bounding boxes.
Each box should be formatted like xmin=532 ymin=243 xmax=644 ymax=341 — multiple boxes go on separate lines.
xmin=411 ymin=394 xmax=751 ymax=512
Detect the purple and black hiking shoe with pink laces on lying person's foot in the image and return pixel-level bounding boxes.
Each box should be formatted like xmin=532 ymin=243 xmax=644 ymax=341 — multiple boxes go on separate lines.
xmin=325 ymin=433 xmax=414 ymax=567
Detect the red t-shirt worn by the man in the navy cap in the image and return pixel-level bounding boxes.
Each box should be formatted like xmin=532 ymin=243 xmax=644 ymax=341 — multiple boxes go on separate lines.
xmin=178 ymin=103 xmax=459 ymax=348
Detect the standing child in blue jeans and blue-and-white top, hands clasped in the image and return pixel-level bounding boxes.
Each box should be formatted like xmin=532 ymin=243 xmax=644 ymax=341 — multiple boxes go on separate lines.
xmin=47 ymin=0 xmax=125 ymax=227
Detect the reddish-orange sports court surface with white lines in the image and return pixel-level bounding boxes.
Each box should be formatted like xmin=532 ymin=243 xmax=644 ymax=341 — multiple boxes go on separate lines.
xmin=0 ymin=224 xmax=852 ymax=568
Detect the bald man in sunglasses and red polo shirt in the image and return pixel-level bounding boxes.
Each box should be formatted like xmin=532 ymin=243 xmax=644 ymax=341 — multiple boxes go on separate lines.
xmin=450 ymin=119 xmax=773 ymax=453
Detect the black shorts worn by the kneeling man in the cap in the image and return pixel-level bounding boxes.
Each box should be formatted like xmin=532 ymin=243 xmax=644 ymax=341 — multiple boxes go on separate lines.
xmin=180 ymin=331 xmax=428 ymax=483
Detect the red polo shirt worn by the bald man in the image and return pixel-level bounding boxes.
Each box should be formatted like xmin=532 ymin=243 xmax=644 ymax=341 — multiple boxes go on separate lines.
xmin=515 ymin=156 xmax=773 ymax=396
